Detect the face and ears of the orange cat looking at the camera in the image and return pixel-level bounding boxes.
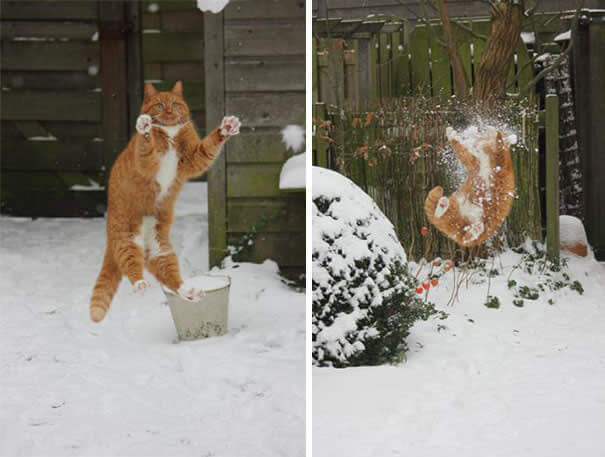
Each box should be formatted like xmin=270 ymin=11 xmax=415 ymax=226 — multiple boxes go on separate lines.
xmin=141 ymin=81 xmax=189 ymax=125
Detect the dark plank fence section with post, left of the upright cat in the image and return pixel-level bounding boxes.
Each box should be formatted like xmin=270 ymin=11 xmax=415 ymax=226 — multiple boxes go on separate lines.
xmin=0 ymin=1 xmax=142 ymax=216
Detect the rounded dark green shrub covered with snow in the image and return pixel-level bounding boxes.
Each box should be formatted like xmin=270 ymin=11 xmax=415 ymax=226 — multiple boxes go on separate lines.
xmin=313 ymin=167 xmax=434 ymax=367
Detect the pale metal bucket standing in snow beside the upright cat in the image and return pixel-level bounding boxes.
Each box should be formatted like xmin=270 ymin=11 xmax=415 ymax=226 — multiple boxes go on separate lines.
xmin=163 ymin=275 xmax=231 ymax=340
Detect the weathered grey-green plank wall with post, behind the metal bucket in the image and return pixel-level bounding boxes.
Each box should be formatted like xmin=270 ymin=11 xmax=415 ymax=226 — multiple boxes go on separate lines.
xmin=204 ymin=0 xmax=305 ymax=274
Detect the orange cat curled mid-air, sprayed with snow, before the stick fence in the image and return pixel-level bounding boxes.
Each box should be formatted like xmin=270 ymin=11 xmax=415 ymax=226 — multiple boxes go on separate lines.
xmin=424 ymin=127 xmax=515 ymax=247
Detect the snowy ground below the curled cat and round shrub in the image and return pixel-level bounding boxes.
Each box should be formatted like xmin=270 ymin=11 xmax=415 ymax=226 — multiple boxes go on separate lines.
xmin=313 ymin=249 xmax=605 ymax=457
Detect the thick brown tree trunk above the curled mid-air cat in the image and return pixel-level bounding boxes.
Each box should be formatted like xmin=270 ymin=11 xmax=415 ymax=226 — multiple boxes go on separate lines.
xmin=473 ymin=0 xmax=523 ymax=102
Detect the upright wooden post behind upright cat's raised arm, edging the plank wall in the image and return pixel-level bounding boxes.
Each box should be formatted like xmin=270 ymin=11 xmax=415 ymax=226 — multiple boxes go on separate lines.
xmin=204 ymin=13 xmax=228 ymax=267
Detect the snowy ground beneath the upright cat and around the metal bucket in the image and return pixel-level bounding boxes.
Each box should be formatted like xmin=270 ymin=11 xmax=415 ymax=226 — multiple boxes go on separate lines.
xmin=0 ymin=183 xmax=305 ymax=457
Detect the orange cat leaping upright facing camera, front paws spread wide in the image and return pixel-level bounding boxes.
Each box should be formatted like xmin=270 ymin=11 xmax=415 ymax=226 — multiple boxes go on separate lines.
xmin=90 ymin=81 xmax=240 ymax=322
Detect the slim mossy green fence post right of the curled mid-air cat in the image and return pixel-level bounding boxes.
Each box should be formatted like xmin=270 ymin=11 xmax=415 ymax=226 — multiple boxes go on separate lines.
xmin=546 ymin=94 xmax=559 ymax=262
